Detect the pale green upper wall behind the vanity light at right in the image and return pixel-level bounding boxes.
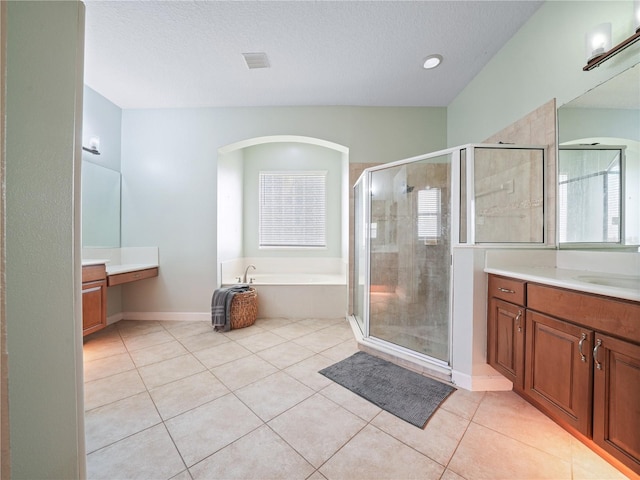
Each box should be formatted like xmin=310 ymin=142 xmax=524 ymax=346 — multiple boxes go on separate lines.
xmin=447 ymin=0 xmax=640 ymax=146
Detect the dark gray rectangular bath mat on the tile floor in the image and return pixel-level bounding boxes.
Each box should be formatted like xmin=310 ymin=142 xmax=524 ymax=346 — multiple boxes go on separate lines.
xmin=319 ymin=352 xmax=455 ymax=428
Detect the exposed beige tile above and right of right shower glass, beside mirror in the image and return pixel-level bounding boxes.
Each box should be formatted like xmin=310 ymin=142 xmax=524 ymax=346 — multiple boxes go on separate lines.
xmin=485 ymin=98 xmax=557 ymax=245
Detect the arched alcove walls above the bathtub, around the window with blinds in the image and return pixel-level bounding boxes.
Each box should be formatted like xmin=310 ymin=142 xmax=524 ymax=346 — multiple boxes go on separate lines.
xmin=217 ymin=135 xmax=349 ymax=284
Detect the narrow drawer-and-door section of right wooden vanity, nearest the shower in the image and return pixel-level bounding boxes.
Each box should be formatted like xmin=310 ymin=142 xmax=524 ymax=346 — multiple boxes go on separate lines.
xmin=487 ymin=275 xmax=526 ymax=391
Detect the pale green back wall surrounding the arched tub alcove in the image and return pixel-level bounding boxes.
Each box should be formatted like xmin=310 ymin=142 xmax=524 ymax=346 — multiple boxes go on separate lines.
xmin=122 ymin=107 xmax=446 ymax=318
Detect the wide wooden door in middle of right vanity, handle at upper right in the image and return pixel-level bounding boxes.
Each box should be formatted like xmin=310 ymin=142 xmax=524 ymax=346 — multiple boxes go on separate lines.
xmin=525 ymin=310 xmax=593 ymax=436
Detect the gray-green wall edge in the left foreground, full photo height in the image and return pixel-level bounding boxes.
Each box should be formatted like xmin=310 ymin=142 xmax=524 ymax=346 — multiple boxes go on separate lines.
xmin=5 ymin=1 xmax=85 ymax=479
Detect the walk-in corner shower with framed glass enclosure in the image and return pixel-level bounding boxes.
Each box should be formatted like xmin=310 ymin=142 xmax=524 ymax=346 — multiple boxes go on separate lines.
xmin=351 ymin=145 xmax=545 ymax=369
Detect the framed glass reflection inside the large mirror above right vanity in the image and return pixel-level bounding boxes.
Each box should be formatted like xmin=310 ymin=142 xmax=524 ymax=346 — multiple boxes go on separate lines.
xmin=558 ymin=145 xmax=624 ymax=243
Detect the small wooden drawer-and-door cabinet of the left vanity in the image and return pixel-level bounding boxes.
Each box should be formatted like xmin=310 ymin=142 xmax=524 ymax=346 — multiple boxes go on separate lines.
xmin=82 ymin=265 xmax=107 ymax=335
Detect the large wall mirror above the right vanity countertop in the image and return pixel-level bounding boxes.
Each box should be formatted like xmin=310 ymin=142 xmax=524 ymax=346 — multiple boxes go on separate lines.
xmin=558 ymin=64 xmax=640 ymax=250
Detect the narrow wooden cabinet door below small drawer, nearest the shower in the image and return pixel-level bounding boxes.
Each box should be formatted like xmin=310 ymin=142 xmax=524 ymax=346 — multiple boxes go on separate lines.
xmin=487 ymin=298 xmax=525 ymax=391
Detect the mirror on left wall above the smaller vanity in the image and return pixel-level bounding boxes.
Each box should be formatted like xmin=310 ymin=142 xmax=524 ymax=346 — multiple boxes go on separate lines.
xmin=82 ymin=160 xmax=120 ymax=248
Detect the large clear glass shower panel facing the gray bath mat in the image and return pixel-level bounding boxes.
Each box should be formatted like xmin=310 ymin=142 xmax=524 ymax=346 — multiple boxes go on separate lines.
xmin=369 ymin=154 xmax=451 ymax=363
